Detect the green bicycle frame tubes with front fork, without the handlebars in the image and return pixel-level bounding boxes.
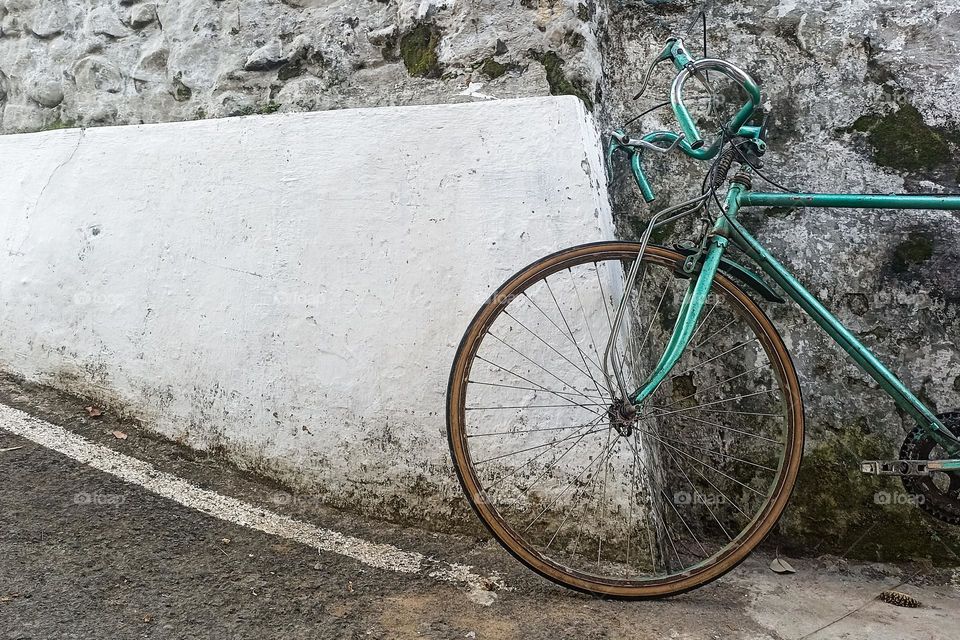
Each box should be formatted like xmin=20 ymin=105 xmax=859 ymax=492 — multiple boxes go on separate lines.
xmin=633 ymin=182 xmax=960 ymax=456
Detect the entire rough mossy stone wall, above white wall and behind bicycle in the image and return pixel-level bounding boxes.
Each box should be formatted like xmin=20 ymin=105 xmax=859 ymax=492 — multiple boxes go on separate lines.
xmin=0 ymin=0 xmax=960 ymax=557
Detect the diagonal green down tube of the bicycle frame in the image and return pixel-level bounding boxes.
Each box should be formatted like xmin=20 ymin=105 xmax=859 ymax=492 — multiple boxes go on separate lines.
xmin=730 ymin=219 xmax=946 ymax=435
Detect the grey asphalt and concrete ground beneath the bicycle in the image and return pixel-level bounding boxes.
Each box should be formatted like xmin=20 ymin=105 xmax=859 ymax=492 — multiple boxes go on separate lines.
xmin=0 ymin=382 xmax=960 ymax=640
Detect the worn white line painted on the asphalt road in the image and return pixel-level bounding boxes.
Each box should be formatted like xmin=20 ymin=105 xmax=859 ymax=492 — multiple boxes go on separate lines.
xmin=0 ymin=405 xmax=509 ymax=603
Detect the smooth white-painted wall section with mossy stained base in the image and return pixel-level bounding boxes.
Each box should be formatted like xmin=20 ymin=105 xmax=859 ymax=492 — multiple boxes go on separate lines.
xmin=0 ymin=97 xmax=612 ymax=517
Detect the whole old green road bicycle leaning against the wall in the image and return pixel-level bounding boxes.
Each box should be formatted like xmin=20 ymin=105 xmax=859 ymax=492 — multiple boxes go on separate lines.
xmin=447 ymin=30 xmax=960 ymax=599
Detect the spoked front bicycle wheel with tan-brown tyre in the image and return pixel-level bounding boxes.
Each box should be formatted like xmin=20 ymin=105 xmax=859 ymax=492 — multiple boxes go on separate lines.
xmin=447 ymin=242 xmax=803 ymax=598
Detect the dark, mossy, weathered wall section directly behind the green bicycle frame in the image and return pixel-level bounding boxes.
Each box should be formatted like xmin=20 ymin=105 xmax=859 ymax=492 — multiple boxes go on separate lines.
xmin=600 ymin=0 xmax=960 ymax=562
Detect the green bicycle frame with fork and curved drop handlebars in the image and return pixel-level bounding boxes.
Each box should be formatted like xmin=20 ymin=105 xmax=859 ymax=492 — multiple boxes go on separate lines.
xmin=607 ymin=37 xmax=960 ymax=456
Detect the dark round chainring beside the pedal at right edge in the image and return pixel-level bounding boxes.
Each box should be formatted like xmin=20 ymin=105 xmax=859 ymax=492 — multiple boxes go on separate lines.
xmin=900 ymin=411 xmax=960 ymax=525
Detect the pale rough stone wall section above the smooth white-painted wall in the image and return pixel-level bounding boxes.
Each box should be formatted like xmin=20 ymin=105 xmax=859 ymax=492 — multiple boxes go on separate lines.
xmin=0 ymin=0 xmax=600 ymax=133
